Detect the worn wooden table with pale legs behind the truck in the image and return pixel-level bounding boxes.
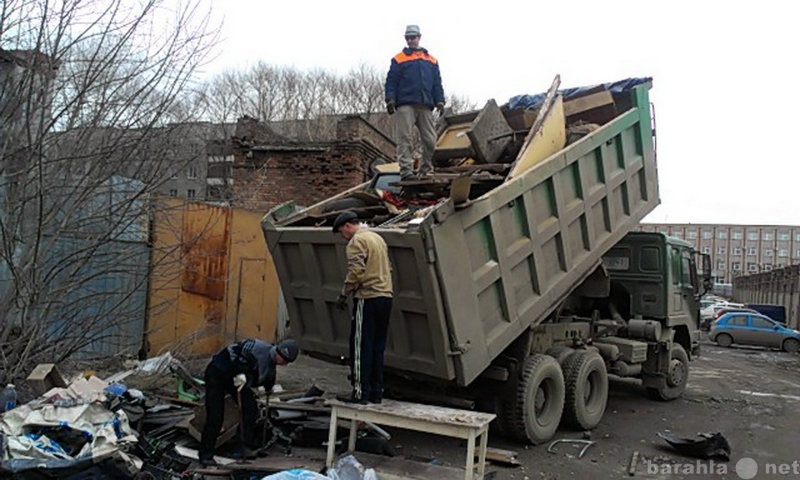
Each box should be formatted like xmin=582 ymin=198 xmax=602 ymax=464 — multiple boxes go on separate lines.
xmin=325 ymin=399 xmax=496 ymax=480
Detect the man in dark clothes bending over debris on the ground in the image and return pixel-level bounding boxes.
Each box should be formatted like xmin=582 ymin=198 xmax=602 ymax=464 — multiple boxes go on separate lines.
xmin=200 ymin=339 xmax=299 ymax=465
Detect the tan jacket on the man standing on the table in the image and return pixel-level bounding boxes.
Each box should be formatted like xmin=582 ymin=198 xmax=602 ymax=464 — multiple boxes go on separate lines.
xmin=342 ymin=227 xmax=392 ymax=298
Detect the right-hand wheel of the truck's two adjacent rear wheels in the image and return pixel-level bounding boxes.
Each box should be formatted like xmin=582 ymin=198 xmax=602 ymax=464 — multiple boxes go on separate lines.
xmin=561 ymin=350 xmax=608 ymax=430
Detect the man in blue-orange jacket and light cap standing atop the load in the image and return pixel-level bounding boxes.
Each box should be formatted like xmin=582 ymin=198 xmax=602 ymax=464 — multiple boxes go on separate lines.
xmin=385 ymin=25 xmax=444 ymax=180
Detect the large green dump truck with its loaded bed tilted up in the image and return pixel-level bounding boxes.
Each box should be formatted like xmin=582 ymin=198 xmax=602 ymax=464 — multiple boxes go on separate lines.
xmin=262 ymin=79 xmax=710 ymax=444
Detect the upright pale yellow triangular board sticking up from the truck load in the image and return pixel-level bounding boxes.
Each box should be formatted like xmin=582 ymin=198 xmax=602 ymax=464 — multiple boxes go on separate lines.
xmin=506 ymin=75 xmax=567 ymax=181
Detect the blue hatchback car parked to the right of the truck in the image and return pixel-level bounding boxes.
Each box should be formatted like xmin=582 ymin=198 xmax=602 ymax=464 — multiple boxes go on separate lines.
xmin=709 ymin=312 xmax=800 ymax=353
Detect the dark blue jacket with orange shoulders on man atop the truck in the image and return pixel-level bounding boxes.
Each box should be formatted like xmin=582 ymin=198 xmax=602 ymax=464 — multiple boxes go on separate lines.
xmin=386 ymin=47 xmax=444 ymax=108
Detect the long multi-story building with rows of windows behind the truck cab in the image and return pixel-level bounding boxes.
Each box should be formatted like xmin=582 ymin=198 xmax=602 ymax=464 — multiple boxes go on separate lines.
xmin=639 ymin=223 xmax=800 ymax=283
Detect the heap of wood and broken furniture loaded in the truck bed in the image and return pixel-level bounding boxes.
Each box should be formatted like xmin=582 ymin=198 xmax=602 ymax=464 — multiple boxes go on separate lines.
xmin=280 ymin=76 xmax=651 ymax=227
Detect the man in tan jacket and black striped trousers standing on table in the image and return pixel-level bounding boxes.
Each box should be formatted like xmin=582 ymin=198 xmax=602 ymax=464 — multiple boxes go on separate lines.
xmin=333 ymin=211 xmax=392 ymax=404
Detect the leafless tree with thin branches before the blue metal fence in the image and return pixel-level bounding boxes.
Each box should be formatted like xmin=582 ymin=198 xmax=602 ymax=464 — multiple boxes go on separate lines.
xmin=0 ymin=0 xmax=215 ymax=381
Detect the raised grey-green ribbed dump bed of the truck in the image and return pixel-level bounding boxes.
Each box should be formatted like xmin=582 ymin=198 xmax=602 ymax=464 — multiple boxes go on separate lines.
xmin=262 ymin=81 xmax=659 ymax=386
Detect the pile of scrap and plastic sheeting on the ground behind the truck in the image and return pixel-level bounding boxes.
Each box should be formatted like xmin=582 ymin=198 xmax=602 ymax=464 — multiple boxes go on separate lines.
xmin=0 ymin=353 xmax=400 ymax=480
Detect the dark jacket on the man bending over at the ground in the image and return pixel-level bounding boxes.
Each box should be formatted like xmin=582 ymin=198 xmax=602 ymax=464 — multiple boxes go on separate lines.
xmin=212 ymin=338 xmax=276 ymax=391
